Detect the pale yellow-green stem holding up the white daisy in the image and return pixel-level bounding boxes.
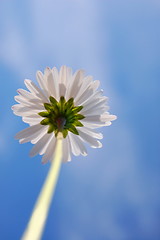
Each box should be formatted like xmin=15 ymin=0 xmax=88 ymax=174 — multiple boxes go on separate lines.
xmin=21 ymin=134 xmax=62 ymax=240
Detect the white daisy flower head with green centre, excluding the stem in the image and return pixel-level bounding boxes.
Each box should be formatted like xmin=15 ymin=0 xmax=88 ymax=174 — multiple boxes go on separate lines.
xmin=12 ymin=66 xmax=116 ymax=163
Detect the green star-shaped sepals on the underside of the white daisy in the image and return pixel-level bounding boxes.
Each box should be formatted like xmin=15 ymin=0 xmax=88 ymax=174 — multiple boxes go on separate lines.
xmin=38 ymin=96 xmax=85 ymax=138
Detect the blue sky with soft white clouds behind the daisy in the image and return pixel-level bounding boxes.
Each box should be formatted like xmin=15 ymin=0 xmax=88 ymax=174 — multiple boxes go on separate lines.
xmin=0 ymin=0 xmax=160 ymax=240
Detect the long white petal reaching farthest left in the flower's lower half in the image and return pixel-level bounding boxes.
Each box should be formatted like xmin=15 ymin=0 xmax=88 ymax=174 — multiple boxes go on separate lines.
xmin=15 ymin=124 xmax=44 ymax=139
